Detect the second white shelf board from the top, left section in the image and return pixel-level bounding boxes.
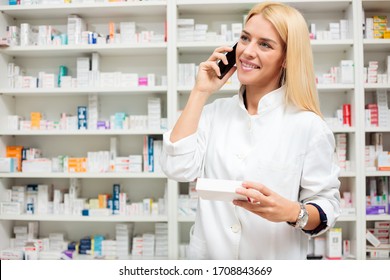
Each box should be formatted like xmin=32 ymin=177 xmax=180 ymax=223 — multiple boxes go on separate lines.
xmin=0 ymin=42 xmax=167 ymax=57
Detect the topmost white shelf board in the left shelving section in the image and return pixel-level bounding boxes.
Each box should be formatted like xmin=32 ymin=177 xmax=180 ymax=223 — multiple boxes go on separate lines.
xmin=0 ymin=1 xmax=167 ymax=20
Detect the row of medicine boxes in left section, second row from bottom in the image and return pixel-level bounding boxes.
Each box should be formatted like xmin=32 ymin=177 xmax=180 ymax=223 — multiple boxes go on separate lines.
xmin=0 ymin=182 xmax=167 ymax=216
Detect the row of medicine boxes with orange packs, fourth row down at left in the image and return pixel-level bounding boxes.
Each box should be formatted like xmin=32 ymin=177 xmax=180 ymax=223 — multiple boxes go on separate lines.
xmin=0 ymin=136 xmax=162 ymax=173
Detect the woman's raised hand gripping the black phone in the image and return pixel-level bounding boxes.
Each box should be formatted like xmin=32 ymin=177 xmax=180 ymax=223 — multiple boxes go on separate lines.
xmin=193 ymin=46 xmax=236 ymax=97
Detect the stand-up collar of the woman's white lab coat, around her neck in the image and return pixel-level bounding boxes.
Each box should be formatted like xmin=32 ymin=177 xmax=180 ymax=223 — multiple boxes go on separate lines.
xmin=238 ymin=85 xmax=286 ymax=115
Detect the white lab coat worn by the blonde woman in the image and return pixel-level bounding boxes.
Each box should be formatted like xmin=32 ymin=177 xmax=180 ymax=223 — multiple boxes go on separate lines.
xmin=161 ymin=87 xmax=340 ymax=259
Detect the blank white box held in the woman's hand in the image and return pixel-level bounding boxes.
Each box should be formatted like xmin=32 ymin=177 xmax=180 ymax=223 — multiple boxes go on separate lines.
xmin=196 ymin=178 xmax=248 ymax=202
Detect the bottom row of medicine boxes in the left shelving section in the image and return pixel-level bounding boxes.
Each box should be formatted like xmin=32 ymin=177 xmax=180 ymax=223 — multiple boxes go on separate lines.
xmin=0 ymin=222 xmax=168 ymax=260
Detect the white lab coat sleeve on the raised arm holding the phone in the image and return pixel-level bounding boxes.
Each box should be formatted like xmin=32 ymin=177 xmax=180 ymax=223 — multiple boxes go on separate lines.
xmin=160 ymin=107 xmax=210 ymax=182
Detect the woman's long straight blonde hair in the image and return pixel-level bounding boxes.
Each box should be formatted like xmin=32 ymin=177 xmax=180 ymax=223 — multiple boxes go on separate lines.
xmin=246 ymin=2 xmax=322 ymax=116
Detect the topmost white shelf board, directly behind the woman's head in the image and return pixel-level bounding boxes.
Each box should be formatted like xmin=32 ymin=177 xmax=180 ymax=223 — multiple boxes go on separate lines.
xmin=176 ymin=0 xmax=352 ymax=14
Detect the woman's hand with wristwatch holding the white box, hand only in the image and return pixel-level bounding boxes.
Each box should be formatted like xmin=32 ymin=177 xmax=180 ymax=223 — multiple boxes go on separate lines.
xmin=233 ymin=182 xmax=300 ymax=222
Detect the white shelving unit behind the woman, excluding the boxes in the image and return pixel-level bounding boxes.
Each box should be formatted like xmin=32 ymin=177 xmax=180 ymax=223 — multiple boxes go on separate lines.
xmin=0 ymin=0 xmax=390 ymax=259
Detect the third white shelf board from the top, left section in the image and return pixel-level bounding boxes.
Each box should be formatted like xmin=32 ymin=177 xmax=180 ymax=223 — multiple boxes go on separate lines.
xmin=0 ymin=86 xmax=168 ymax=96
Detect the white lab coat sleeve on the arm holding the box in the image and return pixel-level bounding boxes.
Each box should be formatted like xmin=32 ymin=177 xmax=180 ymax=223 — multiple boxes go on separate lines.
xmin=299 ymin=124 xmax=340 ymax=236
